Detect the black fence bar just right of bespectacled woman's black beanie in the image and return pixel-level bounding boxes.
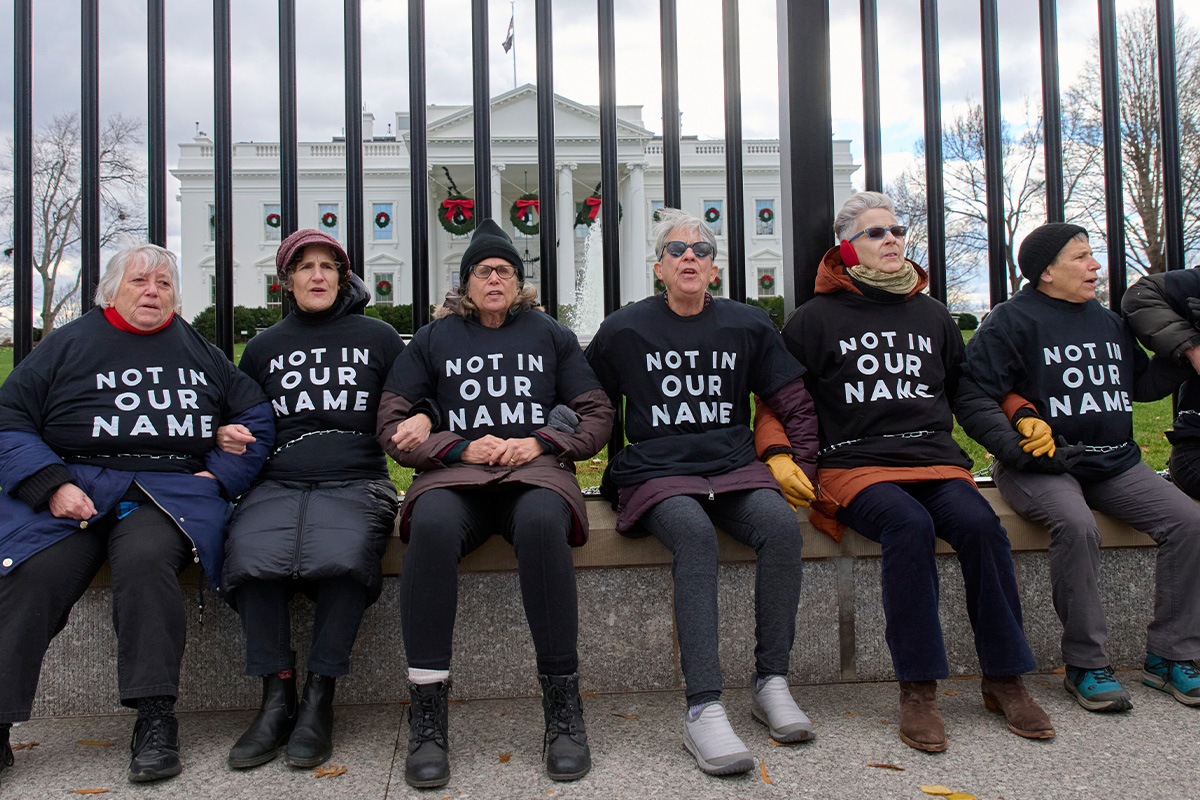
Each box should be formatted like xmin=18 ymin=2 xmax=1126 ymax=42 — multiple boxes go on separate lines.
xmin=534 ymin=0 xmax=558 ymax=318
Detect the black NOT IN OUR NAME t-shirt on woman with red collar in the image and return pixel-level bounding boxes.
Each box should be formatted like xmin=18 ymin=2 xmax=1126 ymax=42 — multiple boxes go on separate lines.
xmin=0 ymin=307 xmax=265 ymax=473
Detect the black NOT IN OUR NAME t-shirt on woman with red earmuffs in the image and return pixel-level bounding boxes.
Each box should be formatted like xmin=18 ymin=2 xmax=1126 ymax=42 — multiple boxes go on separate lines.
xmin=784 ymin=288 xmax=971 ymax=469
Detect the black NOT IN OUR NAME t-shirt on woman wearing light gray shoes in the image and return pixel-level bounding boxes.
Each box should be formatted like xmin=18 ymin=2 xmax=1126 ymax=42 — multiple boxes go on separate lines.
xmin=587 ymin=295 xmax=804 ymax=443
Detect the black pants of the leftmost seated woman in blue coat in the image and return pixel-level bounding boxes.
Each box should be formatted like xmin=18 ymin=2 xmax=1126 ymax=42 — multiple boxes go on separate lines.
xmin=0 ymin=504 xmax=192 ymax=723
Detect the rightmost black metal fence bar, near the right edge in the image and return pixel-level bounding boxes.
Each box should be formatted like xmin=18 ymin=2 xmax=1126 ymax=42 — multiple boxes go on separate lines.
xmin=1158 ymin=0 xmax=1184 ymax=270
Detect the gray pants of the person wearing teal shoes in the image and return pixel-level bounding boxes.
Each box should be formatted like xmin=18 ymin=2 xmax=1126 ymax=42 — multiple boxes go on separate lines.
xmin=995 ymin=462 xmax=1200 ymax=669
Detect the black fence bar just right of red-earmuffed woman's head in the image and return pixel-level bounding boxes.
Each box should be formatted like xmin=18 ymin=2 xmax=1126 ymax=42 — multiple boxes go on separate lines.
xmin=920 ymin=0 xmax=946 ymax=302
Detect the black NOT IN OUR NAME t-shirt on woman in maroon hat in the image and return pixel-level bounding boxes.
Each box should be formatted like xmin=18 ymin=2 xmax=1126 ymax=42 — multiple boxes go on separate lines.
xmin=240 ymin=303 xmax=404 ymax=481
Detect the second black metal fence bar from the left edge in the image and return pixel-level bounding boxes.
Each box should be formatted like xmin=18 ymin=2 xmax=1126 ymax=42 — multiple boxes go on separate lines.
xmin=79 ymin=0 xmax=100 ymax=311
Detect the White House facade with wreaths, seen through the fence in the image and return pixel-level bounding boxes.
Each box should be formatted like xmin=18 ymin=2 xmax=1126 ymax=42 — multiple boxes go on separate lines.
xmin=172 ymin=85 xmax=858 ymax=319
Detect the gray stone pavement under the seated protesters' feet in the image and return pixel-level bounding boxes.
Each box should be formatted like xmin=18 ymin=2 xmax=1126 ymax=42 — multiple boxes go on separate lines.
xmin=0 ymin=670 xmax=1200 ymax=800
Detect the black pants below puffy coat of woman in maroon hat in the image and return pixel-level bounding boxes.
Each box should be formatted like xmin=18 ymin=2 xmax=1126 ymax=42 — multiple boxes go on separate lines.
xmin=234 ymin=577 xmax=367 ymax=678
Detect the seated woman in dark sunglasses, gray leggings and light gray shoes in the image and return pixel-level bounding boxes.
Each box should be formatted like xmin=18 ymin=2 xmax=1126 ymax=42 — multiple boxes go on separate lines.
xmin=587 ymin=209 xmax=816 ymax=775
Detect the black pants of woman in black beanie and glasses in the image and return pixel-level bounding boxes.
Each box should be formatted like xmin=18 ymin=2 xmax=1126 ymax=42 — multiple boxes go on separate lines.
xmin=400 ymin=486 xmax=580 ymax=675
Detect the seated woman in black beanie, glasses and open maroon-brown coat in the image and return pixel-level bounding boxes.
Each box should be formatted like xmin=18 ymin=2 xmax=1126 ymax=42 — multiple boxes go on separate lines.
xmin=379 ymin=219 xmax=612 ymax=787
